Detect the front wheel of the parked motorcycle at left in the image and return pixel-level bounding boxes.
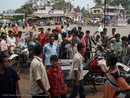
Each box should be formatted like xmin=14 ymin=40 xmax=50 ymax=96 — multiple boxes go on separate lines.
xmin=9 ymin=58 xmax=21 ymax=74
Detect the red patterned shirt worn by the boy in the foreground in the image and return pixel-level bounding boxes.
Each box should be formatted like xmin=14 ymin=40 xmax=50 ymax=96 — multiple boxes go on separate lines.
xmin=47 ymin=65 xmax=67 ymax=97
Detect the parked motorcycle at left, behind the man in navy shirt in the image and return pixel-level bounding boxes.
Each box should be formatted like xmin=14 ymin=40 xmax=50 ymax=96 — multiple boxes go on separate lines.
xmin=9 ymin=42 xmax=31 ymax=74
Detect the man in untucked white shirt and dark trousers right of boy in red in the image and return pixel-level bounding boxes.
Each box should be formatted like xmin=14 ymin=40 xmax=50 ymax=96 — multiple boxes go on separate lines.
xmin=69 ymin=43 xmax=85 ymax=98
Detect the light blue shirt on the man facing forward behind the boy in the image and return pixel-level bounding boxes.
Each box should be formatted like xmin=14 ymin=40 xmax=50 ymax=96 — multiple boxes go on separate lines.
xmin=43 ymin=43 xmax=59 ymax=66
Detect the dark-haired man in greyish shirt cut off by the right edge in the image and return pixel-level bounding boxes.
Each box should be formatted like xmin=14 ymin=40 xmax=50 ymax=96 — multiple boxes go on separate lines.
xmin=121 ymin=36 xmax=130 ymax=65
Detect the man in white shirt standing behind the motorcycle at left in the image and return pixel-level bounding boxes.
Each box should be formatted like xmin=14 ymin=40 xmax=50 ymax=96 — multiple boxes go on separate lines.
xmin=7 ymin=30 xmax=16 ymax=54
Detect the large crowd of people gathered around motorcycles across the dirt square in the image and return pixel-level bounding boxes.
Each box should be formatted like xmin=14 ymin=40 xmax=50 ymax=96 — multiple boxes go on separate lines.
xmin=0 ymin=24 xmax=130 ymax=98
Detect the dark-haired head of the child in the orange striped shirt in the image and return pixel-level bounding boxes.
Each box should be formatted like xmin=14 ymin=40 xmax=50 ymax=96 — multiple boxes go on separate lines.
xmin=106 ymin=53 xmax=118 ymax=67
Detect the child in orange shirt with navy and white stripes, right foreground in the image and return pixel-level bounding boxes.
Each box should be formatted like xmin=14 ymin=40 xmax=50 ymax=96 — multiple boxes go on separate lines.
xmin=103 ymin=53 xmax=130 ymax=98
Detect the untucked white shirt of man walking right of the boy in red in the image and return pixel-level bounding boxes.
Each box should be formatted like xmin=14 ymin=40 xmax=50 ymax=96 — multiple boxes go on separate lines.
xmin=69 ymin=52 xmax=83 ymax=80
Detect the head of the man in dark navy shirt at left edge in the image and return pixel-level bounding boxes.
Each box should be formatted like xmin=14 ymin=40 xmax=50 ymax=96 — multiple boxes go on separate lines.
xmin=0 ymin=55 xmax=9 ymax=69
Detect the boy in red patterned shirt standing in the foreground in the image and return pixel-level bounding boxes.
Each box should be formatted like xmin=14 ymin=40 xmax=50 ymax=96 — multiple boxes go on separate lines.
xmin=47 ymin=55 xmax=67 ymax=98
